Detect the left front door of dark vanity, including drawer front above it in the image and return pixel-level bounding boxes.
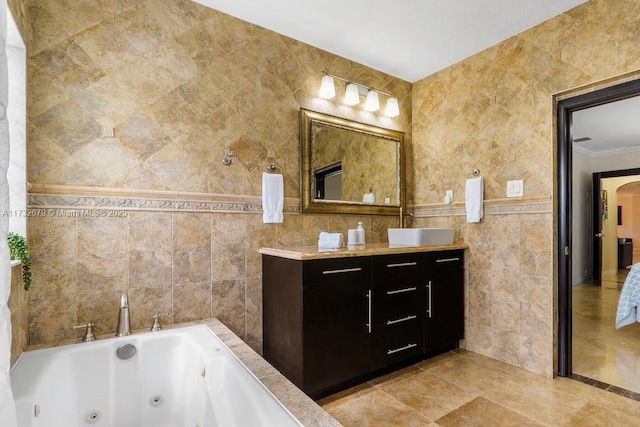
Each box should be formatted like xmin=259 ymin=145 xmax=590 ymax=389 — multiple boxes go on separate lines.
xmin=303 ymin=258 xmax=371 ymax=396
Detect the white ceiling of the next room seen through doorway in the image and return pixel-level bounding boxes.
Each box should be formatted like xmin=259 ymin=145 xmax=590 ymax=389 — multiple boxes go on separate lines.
xmin=572 ymin=96 xmax=640 ymax=156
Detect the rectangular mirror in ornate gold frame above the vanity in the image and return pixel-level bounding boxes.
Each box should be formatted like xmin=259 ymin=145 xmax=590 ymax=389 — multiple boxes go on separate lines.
xmin=300 ymin=109 xmax=405 ymax=215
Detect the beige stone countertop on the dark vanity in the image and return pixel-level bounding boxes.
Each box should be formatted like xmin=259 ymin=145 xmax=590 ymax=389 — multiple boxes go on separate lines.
xmin=260 ymin=243 xmax=469 ymax=260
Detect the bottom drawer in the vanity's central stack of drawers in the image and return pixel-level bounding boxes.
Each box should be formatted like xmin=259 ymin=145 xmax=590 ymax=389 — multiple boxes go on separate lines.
xmin=372 ymin=325 xmax=423 ymax=370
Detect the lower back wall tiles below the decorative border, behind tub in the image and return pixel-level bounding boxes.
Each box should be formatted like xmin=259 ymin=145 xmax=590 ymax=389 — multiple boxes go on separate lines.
xmin=29 ymin=211 xmax=397 ymax=349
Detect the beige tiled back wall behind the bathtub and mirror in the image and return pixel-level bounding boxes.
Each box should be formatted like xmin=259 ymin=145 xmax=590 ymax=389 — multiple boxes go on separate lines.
xmin=21 ymin=0 xmax=411 ymax=349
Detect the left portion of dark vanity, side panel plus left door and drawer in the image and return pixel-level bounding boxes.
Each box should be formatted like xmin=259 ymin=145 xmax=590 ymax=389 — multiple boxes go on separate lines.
xmin=262 ymin=255 xmax=371 ymax=396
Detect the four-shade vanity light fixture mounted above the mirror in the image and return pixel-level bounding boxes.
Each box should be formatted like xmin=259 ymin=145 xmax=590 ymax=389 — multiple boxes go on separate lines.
xmin=318 ymin=71 xmax=400 ymax=117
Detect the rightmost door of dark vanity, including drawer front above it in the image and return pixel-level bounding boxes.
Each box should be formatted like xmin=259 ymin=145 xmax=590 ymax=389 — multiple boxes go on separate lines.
xmin=424 ymin=251 xmax=464 ymax=353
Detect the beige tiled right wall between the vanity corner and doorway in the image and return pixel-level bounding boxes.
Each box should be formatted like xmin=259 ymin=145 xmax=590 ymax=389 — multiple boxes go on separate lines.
xmin=412 ymin=0 xmax=640 ymax=376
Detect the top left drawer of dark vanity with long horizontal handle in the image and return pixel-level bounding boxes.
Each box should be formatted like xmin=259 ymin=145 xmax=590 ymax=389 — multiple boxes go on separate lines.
xmin=302 ymin=257 xmax=371 ymax=287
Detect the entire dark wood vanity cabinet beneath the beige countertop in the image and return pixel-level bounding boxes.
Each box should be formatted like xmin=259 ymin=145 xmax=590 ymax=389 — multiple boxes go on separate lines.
xmin=262 ymin=250 xmax=464 ymax=397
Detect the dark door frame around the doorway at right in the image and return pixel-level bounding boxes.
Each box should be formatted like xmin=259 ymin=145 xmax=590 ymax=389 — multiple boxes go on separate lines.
xmin=556 ymin=79 xmax=640 ymax=377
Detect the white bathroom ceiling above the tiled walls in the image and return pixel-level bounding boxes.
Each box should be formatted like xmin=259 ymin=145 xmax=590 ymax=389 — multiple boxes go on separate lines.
xmin=196 ymin=0 xmax=586 ymax=83
